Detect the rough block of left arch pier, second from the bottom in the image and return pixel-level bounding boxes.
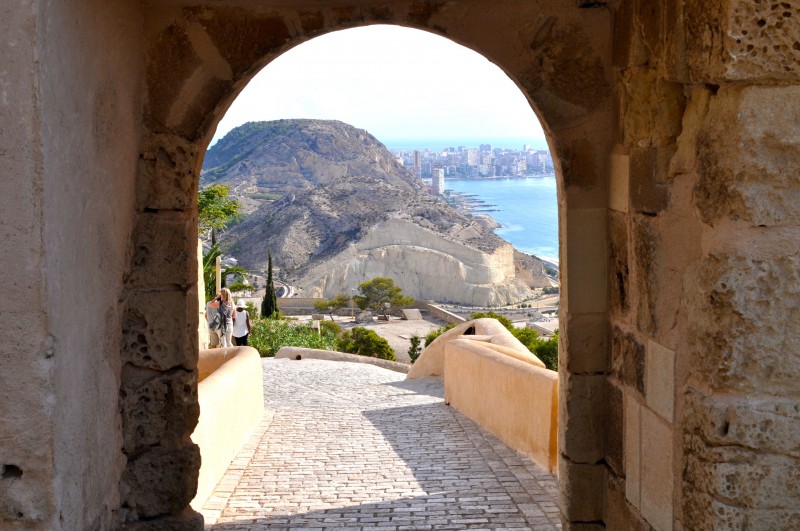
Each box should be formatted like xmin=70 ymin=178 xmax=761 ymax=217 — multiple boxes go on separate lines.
xmin=119 ymin=364 xmax=200 ymax=456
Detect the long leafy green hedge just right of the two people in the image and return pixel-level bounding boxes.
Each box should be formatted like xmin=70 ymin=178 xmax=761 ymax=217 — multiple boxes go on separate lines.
xmin=250 ymin=319 xmax=336 ymax=358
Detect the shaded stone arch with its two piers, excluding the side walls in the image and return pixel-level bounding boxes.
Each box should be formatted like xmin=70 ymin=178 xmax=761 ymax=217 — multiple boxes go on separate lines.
xmin=121 ymin=2 xmax=614 ymax=520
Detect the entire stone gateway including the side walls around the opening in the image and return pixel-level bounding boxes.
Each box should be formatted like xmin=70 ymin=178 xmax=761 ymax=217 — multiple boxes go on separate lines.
xmin=9 ymin=0 xmax=800 ymax=529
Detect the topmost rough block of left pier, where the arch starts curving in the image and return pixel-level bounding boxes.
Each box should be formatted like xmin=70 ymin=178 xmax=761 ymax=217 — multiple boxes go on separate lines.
xmin=136 ymin=134 xmax=199 ymax=211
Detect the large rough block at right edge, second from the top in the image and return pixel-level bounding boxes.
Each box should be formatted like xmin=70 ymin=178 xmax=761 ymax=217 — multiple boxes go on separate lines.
xmin=695 ymin=84 xmax=800 ymax=226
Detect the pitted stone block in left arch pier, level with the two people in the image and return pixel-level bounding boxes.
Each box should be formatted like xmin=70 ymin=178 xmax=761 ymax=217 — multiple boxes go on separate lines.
xmin=122 ymin=290 xmax=197 ymax=371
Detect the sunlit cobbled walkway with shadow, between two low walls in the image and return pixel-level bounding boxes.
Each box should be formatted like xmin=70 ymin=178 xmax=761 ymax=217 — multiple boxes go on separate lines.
xmin=203 ymin=359 xmax=561 ymax=531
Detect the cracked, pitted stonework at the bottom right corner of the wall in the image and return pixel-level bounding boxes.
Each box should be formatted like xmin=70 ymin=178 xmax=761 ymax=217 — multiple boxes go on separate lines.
xmin=683 ymin=388 xmax=800 ymax=530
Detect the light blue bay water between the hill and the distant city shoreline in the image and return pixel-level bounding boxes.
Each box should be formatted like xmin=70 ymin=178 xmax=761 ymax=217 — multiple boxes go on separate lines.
xmin=445 ymin=174 xmax=558 ymax=263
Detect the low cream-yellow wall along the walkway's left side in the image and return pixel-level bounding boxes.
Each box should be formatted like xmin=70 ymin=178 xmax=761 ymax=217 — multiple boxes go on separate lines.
xmin=192 ymin=347 xmax=265 ymax=510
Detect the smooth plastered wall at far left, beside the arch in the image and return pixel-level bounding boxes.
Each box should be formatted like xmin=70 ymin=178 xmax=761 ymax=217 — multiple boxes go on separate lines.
xmin=0 ymin=1 xmax=143 ymax=529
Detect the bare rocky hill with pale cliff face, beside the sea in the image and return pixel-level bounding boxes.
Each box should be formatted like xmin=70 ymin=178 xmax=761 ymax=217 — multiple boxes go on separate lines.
xmin=201 ymin=120 xmax=548 ymax=305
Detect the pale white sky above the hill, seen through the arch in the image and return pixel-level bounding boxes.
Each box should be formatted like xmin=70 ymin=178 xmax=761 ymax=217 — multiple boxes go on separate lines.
xmin=212 ymin=25 xmax=547 ymax=149
